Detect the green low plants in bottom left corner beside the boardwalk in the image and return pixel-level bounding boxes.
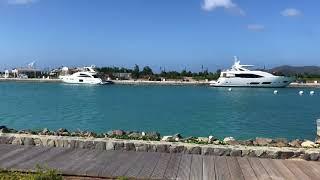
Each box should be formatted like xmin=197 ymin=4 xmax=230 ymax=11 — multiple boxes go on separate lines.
xmin=0 ymin=167 xmax=63 ymax=180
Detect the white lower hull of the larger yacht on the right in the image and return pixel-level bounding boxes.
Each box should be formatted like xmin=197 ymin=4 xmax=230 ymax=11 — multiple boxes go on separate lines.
xmin=210 ymin=76 xmax=294 ymax=88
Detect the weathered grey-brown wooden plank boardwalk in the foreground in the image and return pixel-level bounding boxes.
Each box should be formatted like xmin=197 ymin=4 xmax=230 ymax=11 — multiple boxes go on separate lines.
xmin=0 ymin=144 xmax=320 ymax=180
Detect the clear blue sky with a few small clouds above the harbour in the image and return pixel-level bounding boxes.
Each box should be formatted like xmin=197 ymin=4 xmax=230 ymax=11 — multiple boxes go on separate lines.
xmin=0 ymin=0 xmax=320 ymax=71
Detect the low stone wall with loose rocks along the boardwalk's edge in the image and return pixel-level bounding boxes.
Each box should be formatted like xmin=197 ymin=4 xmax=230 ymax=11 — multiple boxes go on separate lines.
xmin=0 ymin=126 xmax=320 ymax=161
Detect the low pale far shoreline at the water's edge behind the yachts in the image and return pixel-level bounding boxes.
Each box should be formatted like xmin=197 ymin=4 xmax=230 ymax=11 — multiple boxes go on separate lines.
xmin=0 ymin=78 xmax=320 ymax=88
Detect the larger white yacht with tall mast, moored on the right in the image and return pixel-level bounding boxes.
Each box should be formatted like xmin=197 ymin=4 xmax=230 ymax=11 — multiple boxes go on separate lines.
xmin=210 ymin=56 xmax=294 ymax=87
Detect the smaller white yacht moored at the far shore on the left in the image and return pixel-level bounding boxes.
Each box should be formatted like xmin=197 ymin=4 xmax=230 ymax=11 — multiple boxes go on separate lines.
xmin=59 ymin=66 xmax=103 ymax=84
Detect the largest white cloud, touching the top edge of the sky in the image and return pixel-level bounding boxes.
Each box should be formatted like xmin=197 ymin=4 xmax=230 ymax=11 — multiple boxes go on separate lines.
xmin=201 ymin=0 xmax=246 ymax=16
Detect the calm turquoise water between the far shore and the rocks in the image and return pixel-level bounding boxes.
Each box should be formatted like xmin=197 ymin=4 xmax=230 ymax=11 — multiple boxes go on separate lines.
xmin=0 ymin=82 xmax=320 ymax=139
